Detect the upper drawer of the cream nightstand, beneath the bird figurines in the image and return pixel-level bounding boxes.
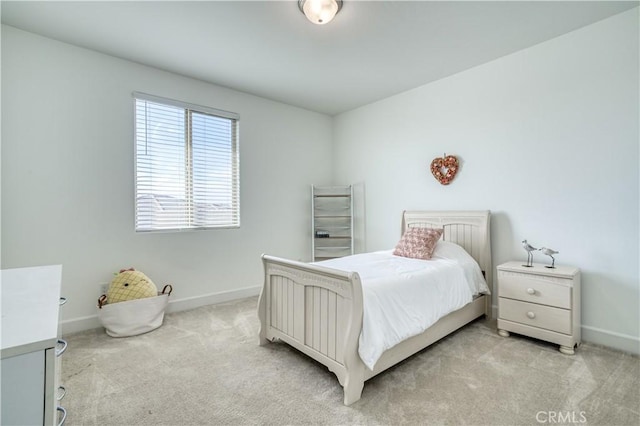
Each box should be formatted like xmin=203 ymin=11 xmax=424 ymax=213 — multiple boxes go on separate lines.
xmin=498 ymin=271 xmax=571 ymax=309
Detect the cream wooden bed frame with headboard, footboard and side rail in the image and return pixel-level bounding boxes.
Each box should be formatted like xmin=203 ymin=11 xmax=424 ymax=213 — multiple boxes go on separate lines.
xmin=258 ymin=211 xmax=492 ymax=405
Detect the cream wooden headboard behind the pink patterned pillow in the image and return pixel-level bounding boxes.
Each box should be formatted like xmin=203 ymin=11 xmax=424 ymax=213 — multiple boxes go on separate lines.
xmin=402 ymin=210 xmax=493 ymax=290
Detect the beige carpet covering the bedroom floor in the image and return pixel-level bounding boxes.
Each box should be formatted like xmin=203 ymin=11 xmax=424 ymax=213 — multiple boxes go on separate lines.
xmin=62 ymin=298 xmax=640 ymax=426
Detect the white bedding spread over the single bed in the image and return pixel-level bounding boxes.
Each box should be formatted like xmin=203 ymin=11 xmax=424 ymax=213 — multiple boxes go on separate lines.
xmin=317 ymin=241 xmax=489 ymax=370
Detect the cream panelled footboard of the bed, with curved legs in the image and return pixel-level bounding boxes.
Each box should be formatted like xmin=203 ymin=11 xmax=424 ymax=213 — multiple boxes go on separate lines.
xmin=258 ymin=255 xmax=366 ymax=405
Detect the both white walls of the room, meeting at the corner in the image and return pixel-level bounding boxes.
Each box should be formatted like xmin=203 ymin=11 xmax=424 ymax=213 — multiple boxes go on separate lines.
xmin=1 ymin=8 xmax=640 ymax=352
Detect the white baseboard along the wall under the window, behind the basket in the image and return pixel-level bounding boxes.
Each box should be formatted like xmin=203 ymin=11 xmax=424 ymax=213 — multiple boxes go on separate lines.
xmin=60 ymin=286 xmax=262 ymax=335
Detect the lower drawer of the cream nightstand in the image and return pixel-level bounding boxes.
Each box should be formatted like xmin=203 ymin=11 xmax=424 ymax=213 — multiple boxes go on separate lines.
xmin=498 ymin=297 xmax=571 ymax=334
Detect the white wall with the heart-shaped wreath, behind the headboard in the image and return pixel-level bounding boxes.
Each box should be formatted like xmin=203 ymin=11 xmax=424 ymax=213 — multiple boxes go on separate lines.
xmin=334 ymin=8 xmax=640 ymax=352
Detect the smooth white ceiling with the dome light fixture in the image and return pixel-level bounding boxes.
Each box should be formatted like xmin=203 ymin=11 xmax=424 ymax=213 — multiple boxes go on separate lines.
xmin=1 ymin=0 xmax=639 ymax=115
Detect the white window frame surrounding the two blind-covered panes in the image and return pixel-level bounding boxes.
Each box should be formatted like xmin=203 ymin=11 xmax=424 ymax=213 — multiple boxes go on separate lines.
xmin=132 ymin=92 xmax=241 ymax=233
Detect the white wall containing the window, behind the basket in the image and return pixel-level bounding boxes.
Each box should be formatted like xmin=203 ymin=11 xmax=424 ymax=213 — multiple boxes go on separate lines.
xmin=1 ymin=26 xmax=332 ymax=331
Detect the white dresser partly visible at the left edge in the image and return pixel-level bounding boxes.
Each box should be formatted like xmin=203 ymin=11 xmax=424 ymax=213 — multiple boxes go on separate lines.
xmin=0 ymin=265 xmax=66 ymax=425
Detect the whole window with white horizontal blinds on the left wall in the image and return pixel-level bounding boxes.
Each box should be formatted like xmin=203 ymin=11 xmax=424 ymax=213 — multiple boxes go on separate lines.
xmin=134 ymin=93 xmax=240 ymax=231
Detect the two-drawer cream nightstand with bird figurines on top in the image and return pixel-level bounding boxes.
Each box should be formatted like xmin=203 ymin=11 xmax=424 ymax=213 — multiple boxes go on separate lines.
xmin=497 ymin=262 xmax=580 ymax=355
